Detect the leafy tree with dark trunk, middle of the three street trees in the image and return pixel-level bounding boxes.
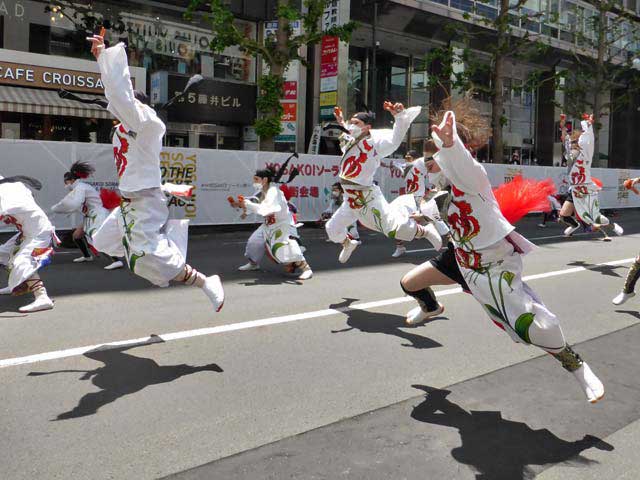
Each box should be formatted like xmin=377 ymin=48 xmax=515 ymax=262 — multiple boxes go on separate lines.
xmin=428 ymin=0 xmax=555 ymax=163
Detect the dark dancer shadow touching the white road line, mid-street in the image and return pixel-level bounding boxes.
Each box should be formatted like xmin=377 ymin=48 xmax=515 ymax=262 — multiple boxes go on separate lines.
xmin=329 ymin=298 xmax=444 ymax=349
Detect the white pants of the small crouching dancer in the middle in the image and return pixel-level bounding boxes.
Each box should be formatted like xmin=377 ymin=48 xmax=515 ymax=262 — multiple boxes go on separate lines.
xmin=244 ymin=223 xmax=305 ymax=264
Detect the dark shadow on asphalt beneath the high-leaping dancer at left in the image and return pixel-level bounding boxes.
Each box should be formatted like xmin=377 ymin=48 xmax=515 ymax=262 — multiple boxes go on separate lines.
xmin=28 ymin=335 xmax=223 ymax=421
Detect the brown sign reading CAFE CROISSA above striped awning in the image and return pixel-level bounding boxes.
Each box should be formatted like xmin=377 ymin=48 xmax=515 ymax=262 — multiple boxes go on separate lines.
xmin=0 ymin=61 xmax=104 ymax=94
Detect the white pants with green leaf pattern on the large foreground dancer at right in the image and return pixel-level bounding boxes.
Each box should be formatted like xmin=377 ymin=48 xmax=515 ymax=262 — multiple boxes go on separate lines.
xmin=456 ymin=239 xmax=566 ymax=353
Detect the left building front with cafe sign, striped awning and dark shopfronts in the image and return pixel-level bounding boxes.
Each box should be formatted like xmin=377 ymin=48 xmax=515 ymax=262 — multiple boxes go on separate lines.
xmin=0 ymin=0 xmax=282 ymax=149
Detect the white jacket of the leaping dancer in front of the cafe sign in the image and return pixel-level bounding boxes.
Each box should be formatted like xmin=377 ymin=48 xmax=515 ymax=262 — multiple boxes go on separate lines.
xmin=98 ymin=43 xmax=165 ymax=192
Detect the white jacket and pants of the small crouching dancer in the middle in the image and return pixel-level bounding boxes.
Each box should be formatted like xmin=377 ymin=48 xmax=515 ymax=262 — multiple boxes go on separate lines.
xmin=245 ymin=185 xmax=304 ymax=264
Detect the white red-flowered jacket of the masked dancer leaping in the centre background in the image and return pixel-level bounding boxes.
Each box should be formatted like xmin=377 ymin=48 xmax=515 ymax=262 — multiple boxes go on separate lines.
xmin=340 ymin=107 xmax=422 ymax=187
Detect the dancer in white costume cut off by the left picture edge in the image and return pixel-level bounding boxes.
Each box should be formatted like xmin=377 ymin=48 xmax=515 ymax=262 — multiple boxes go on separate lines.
xmin=0 ymin=176 xmax=57 ymax=313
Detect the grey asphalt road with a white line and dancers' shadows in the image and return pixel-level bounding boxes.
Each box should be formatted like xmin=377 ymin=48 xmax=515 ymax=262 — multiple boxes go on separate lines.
xmin=0 ymin=211 xmax=640 ymax=480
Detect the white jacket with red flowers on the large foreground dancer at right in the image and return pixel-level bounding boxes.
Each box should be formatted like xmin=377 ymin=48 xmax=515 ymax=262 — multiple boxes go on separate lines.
xmin=434 ymin=112 xmax=516 ymax=262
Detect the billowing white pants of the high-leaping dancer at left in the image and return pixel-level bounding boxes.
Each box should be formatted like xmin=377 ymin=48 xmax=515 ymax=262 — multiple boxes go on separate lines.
xmin=93 ymin=188 xmax=189 ymax=287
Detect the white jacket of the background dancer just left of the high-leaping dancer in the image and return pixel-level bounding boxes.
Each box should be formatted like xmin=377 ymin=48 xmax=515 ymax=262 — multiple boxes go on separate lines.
xmin=51 ymin=180 xmax=109 ymax=240
